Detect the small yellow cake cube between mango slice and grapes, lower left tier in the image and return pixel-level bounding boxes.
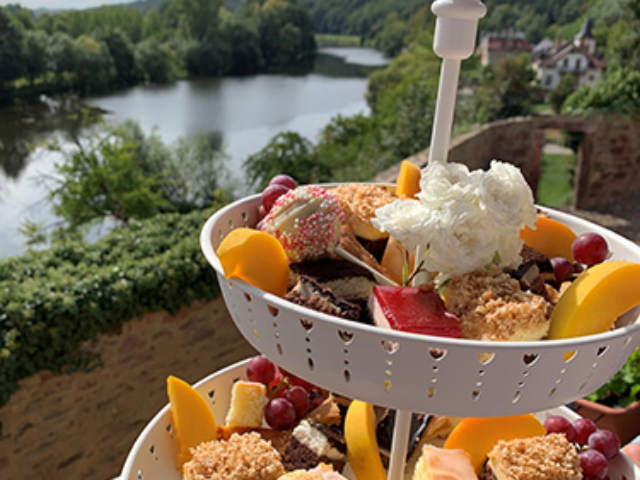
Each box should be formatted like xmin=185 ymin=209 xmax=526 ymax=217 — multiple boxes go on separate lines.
xmin=226 ymin=380 xmax=269 ymax=428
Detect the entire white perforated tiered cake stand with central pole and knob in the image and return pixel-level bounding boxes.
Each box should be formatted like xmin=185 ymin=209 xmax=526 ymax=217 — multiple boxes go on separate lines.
xmin=123 ymin=0 xmax=640 ymax=480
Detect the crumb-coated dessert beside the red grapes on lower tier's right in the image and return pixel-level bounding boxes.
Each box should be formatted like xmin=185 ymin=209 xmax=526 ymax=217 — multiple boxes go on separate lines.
xmin=483 ymin=433 xmax=583 ymax=480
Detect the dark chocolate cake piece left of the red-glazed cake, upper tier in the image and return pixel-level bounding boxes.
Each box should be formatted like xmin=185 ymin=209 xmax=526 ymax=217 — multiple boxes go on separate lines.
xmin=285 ymin=275 xmax=361 ymax=320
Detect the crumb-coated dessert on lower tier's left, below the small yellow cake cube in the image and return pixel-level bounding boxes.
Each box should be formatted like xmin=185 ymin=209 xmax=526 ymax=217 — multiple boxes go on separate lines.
xmin=182 ymin=432 xmax=286 ymax=480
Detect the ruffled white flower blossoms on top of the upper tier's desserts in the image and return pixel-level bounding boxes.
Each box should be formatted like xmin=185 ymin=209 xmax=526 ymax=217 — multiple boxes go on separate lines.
xmin=372 ymin=160 xmax=536 ymax=278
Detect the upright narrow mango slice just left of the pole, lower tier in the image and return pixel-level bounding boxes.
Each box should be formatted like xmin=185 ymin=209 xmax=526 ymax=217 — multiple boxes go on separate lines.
xmin=344 ymin=400 xmax=387 ymax=480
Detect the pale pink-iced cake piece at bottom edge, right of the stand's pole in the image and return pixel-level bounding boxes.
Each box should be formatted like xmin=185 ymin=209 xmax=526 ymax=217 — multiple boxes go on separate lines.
xmin=412 ymin=445 xmax=478 ymax=480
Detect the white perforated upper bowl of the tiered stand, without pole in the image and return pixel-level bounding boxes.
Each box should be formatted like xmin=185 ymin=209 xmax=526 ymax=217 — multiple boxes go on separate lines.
xmin=200 ymin=189 xmax=640 ymax=416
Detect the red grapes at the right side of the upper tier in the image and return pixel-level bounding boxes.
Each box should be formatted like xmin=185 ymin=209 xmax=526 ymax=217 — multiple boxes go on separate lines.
xmin=551 ymin=232 xmax=609 ymax=284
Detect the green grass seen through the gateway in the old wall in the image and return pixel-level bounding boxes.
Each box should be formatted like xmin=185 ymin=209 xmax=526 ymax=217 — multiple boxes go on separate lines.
xmin=536 ymin=153 xmax=576 ymax=207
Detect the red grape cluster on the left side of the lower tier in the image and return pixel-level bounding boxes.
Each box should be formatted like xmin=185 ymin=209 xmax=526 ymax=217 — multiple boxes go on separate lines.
xmin=247 ymin=355 xmax=324 ymax=430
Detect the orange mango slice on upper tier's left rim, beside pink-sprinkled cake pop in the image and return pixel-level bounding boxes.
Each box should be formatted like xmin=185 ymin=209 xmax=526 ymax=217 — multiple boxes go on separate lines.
xmin=216 ymin=228 xmax=289 ymax=297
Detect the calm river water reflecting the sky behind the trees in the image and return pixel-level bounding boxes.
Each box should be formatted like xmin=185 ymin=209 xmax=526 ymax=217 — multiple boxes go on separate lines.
xmin=0 ymin=48 xmax=385 ymax=257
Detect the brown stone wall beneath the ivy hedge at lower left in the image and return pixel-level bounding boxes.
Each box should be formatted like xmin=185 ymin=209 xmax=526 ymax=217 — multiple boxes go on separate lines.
xmin=0 ymin=299 xmax=255 ymax=480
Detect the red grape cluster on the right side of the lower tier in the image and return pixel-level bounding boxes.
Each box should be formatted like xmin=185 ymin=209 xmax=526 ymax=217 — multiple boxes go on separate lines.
xmin=544 ymin=415 xmax=620 ymax=480
